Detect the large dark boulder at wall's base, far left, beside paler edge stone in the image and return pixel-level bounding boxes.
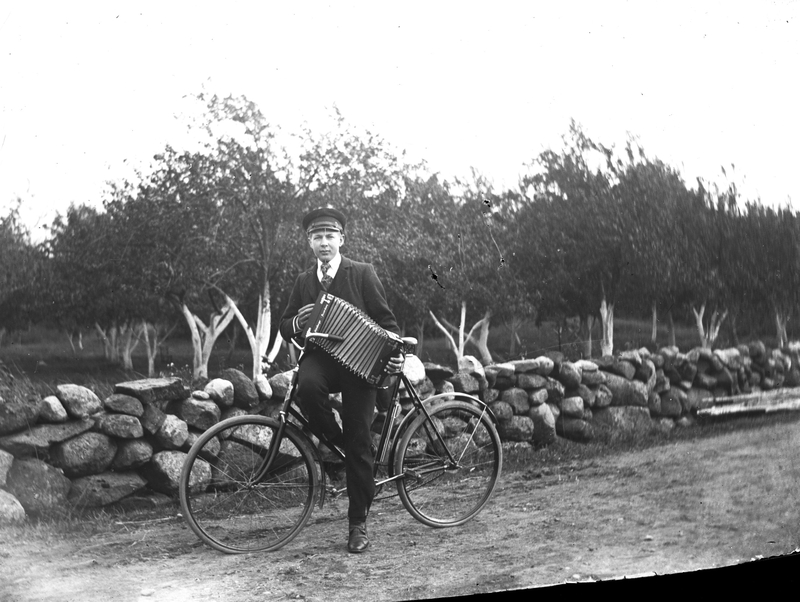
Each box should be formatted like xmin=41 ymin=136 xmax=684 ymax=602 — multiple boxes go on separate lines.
xmin=6 ymin=458 xmax=72 ymax=516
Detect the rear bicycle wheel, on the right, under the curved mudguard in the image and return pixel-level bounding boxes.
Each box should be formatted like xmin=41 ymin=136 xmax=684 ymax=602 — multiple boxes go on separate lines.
xmin=395 ymin=401 xmax=503 ymax=527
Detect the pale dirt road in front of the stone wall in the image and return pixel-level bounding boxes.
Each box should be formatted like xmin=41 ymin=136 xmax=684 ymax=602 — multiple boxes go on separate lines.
xmin=0 ymin=412 xmax=800 ymax=602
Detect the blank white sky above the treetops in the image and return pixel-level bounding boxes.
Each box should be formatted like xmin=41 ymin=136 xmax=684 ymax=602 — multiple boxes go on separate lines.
xmin=0 ymin=0 xmax=800 ymax=238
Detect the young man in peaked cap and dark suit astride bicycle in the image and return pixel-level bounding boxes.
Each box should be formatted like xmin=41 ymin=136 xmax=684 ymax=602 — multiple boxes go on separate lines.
xmin=280 ymin=207 xmax=403 ymax=553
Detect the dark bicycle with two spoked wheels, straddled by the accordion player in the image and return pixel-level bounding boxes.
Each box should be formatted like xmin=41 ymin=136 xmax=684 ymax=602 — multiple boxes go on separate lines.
xmin=180 ymin=335 xmax=503 ymax=554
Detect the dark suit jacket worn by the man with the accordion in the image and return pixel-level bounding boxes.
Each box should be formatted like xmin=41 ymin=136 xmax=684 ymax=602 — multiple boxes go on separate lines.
xmin=280 ymin=256 xmax=400 ymax=341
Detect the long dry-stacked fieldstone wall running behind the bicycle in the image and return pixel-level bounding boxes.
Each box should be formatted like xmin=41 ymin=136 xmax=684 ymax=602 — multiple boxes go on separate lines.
xmin=0 ymin=343 xmax=800 ymax=521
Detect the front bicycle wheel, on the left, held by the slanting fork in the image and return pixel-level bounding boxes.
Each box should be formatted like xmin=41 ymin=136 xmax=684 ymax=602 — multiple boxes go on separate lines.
xmin=180 ymin=415 xmax=319 ymax=554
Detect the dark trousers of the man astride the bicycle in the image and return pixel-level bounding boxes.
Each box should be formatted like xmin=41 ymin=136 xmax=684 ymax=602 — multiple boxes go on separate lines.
xmin=297 ymin=349 xmax=377 ymax=521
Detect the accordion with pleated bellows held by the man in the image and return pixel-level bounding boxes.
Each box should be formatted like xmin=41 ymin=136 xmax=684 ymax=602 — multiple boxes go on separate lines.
xmin=303 ymin=291 xmax=403 ymax=386
